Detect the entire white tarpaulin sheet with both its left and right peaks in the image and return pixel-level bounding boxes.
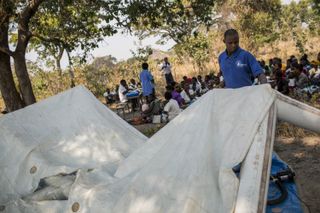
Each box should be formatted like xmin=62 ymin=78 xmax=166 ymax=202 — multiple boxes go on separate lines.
xmin=0 ymin=85 xmax=275 ymax=213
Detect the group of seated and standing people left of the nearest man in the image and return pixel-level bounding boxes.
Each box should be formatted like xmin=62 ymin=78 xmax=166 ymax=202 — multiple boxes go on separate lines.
xmin=104 ymin=58 xmax=220 ymax=122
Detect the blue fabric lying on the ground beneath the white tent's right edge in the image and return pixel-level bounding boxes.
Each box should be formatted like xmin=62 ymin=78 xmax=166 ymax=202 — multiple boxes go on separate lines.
xmin=266 ymin=153 xmax=303 ymax=213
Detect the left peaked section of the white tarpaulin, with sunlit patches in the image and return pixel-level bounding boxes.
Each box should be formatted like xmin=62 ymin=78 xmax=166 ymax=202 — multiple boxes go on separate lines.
xmin=0 ymin=86 xmax=147 ymax=210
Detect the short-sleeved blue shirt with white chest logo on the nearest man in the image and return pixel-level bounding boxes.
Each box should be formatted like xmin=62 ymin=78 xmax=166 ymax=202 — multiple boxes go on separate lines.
xmin=219 ymin=47 xmax=263 ymax=88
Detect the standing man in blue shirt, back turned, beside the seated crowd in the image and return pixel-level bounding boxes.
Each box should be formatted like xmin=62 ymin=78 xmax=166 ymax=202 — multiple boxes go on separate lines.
xmin=140 ymin=63 xmax=155 ymax=97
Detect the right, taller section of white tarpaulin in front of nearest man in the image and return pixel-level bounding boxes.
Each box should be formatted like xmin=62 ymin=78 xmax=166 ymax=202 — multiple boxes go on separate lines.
xmin=64 ymin=86 xmax=275 ymax=213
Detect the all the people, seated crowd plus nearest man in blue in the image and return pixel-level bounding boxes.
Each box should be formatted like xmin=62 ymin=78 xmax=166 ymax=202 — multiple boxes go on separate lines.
xmin=105 ymin=29 xmax=320 ymax=125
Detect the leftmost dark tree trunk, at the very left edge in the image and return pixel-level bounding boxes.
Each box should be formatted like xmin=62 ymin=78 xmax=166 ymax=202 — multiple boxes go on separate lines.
xmin=0 ymin=18 xmax=24 ymax=112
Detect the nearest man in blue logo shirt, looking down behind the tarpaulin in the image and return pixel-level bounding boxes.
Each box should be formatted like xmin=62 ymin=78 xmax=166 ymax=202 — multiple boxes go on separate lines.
xmin=219 ymin=29 xmax=267 ymax=88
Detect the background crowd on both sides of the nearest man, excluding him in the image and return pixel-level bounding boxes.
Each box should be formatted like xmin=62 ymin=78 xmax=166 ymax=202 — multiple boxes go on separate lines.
xmin=104 ymin=53 xmax=320 ymax=122
